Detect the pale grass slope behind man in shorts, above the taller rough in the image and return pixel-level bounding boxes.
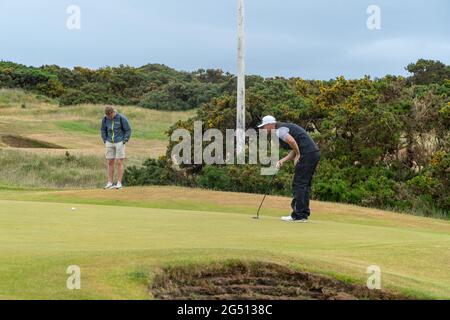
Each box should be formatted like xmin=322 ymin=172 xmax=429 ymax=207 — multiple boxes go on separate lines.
xmin=0 ymin=89 xmax=195 ymax=164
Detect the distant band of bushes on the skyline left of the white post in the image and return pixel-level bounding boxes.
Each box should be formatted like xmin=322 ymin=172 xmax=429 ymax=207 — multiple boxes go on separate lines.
xmin=0 ymin=62 xmax=232 ymax=110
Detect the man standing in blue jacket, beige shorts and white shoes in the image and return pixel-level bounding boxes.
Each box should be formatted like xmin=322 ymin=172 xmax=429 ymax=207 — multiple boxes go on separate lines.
xmin=101 ymin=106 xmax=131 ymax=189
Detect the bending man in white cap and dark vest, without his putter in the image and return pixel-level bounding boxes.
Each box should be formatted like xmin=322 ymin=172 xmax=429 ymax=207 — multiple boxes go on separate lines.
xmin=259 ymin=116 xmax=320 ymax=223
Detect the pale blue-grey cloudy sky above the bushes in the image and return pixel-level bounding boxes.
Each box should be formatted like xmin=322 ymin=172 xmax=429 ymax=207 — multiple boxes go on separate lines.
xmin=0 ymin=0 xmax=450 ymax=79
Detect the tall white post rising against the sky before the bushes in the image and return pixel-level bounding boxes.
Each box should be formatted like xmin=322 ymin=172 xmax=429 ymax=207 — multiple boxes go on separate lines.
xmin=236 ymin=0 xmax=245 ymax=163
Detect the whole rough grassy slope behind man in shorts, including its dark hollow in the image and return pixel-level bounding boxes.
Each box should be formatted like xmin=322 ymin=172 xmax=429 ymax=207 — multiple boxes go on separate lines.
xmin=0 ymin=89 xmax=195 ymax=188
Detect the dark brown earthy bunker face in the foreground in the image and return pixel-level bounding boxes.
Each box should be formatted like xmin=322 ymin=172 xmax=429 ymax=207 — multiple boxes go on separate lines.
xmin=150 ymin=261 xmax=405 ymax=300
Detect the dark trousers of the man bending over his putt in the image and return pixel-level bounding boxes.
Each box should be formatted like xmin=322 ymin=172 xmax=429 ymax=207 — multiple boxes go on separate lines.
xmin=291 ymin=151 xmax=320 ymax=219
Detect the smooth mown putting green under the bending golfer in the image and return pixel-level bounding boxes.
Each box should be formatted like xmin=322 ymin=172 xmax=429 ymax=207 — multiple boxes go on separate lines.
xmin=0 ymin=187 xmax=450 ymax=299
